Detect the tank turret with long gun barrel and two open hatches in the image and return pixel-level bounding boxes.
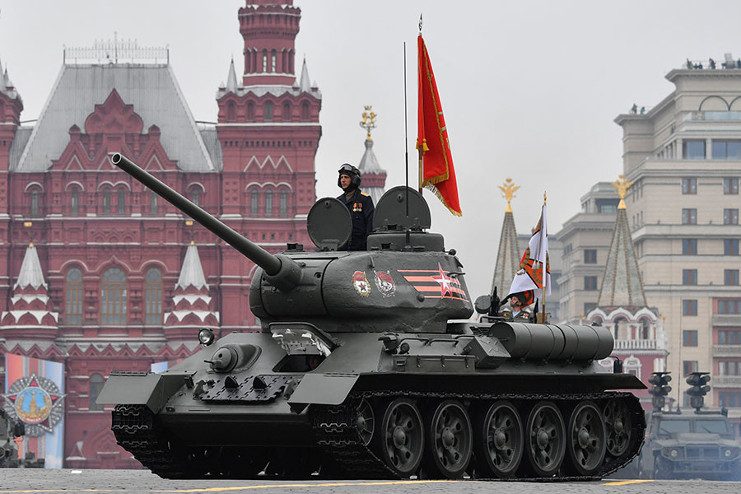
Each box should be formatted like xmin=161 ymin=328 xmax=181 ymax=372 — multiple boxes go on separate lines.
xmin=111 ymin=153 xmax=473 ymax=333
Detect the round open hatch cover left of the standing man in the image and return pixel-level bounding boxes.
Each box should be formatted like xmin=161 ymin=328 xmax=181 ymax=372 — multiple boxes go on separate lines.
xmin=306 ymin=197 xmax=352 ymax=250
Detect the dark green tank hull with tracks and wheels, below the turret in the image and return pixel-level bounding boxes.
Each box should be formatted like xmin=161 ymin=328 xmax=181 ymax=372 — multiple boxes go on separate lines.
xmin=99 ymin=332 xmax=645 ymax=479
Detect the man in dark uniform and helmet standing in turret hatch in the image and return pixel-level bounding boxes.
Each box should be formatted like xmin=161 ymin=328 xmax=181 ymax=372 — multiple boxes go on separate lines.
xmin=337 ymin=163 xmax=374 ymax=250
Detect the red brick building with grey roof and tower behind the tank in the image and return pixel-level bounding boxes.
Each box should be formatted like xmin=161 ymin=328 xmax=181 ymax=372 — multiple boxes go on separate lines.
xmin=0 ymin=0 xmax=321 ymax=468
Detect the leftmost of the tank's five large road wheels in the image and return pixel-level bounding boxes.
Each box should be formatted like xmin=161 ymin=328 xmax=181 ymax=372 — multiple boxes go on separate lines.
xmin=379 ymin=398 xmax=424 ymax=477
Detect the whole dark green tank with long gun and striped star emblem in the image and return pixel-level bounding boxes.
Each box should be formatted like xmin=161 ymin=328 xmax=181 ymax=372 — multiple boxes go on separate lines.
xmin=97 ymin=154 xmax=645 ymax=479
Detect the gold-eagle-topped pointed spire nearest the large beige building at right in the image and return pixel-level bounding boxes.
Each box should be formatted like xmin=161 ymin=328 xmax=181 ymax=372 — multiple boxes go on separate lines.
xmin=597 ymin=175 xmax=646 ymax=307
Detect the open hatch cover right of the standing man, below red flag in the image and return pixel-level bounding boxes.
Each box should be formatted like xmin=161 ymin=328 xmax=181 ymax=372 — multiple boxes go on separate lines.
xmin=373 ymin=185 xmax=432 ymax=231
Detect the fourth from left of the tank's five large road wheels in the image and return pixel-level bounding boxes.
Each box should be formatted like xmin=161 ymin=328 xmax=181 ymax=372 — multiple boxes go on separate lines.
xmin=526 ymin=401 xmax=566 ymax=477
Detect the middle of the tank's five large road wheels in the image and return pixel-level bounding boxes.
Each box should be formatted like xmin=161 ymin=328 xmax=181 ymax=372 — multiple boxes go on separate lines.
xmin=474 ymin=401 xmax=525 ymax=478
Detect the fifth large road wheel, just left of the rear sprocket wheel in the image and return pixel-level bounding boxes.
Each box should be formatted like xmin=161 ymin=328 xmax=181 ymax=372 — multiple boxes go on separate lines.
xmin=568 ymin=401 xmax=607 ymax=476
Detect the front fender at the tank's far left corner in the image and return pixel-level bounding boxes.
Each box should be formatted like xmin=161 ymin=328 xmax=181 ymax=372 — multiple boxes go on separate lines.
xmin=96 ymin=371 xmax=194 ymax=413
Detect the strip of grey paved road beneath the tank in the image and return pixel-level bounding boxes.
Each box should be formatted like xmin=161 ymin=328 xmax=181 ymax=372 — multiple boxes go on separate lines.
xmin=0 ymin=469 xmax=741 ymax=494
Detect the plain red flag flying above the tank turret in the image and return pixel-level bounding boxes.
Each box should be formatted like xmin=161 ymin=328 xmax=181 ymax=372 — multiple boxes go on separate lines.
xmin=417 ymin=34 xmax=461 ymax=216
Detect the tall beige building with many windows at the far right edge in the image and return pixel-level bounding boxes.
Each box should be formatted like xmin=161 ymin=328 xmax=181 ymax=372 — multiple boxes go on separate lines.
xmin=615 ymin=61 xmax=741 ymax=417
